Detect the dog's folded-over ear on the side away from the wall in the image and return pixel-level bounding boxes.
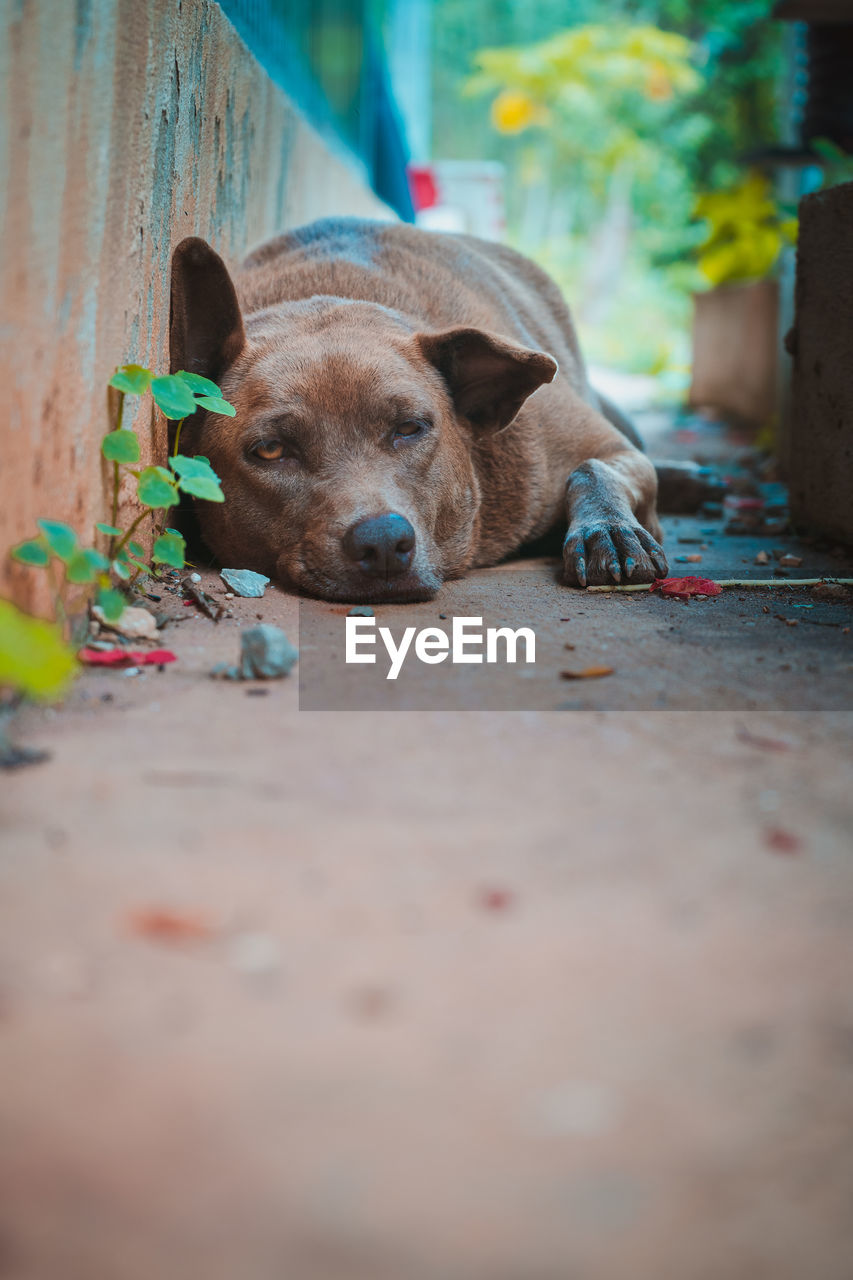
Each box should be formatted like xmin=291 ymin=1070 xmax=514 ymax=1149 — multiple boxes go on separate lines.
xmin=416 ymin=329 xmax=557 ymax=431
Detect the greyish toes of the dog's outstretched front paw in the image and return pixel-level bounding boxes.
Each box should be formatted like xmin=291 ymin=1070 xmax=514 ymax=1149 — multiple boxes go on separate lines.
xmin=562 ymin=521 xmax=669 ymax=586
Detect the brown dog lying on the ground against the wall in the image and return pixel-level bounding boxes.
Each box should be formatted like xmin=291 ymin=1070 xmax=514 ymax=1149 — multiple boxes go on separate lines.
xmin=170 ymin=219 xmax=666 ymax=602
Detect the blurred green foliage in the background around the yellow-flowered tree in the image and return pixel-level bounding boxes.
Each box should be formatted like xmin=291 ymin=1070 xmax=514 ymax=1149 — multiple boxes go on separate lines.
xmin=433 ymin=0 xmax=785 ymax=384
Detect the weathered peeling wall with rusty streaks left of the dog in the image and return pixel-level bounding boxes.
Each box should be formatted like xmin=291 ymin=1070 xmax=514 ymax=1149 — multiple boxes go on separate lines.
xmin=0 ymin=0 xmax=383 ymax=603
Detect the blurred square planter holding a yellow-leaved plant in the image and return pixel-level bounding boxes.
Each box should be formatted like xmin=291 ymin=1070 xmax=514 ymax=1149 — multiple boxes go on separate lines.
xmin=690 ymin=173 xmax=797 ymax=428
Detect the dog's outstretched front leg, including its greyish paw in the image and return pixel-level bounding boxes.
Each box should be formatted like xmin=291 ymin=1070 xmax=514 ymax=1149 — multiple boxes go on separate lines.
xmin=562 ymin=442 xmax=667 ymax=586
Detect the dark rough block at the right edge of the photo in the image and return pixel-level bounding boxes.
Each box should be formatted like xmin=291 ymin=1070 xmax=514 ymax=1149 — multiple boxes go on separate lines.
xmin=789 ymin=182 xmax=853 ymax=543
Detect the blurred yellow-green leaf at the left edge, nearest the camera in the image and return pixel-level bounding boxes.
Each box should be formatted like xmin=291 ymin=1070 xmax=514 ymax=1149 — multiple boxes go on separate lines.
xmin=0 ymin=600 xmax=77 ymax=701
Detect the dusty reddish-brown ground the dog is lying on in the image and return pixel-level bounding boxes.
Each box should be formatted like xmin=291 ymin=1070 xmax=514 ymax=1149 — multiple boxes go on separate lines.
xmin=0 ymin=414 xmax=853 ymax=1280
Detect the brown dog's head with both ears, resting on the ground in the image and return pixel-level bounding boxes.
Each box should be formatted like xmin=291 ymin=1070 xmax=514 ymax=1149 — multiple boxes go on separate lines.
xmin=170 ymin=238 xmax=557 ymax=602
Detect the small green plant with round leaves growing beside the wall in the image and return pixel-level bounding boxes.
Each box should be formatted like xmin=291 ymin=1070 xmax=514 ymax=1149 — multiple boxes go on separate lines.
xmin=10 ymin=365 xmax=234 ymax=632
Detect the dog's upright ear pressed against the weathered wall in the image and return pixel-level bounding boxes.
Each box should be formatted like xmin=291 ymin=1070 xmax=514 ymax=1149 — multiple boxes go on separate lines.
xmin=169 ymin=236 xmax=246 ymax=381
